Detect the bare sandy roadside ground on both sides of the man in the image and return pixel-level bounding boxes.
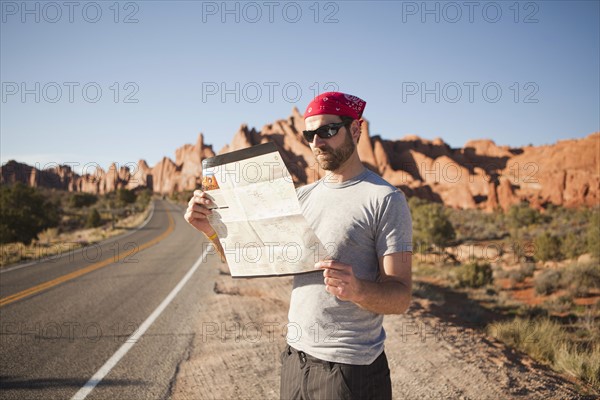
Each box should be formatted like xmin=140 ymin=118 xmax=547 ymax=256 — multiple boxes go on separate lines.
xmin=171 ymin=265 xmax=598 ymax=400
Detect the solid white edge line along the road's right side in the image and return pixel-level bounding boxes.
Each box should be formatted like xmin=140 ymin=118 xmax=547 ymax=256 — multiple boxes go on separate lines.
xmin=71 ymin=246 xmax=210 ymax=400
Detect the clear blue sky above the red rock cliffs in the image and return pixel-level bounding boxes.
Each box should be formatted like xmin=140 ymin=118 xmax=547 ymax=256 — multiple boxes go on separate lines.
xmin=0 ymin=1 xmax=600 ymax=173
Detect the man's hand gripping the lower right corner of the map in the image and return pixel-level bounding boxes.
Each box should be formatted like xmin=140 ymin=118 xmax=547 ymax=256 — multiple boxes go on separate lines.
xmin=315 ymin=260 xmax=362 ymax=303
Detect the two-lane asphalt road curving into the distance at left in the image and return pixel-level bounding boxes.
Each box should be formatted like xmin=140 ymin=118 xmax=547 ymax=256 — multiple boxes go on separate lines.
xmin=0 ymin=201 xmax=218 ymax=399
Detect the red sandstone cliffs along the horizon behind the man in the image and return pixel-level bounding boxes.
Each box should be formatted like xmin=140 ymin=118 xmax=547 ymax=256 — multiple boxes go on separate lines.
xmin=0 ymin=108 xmax=600 ymax=210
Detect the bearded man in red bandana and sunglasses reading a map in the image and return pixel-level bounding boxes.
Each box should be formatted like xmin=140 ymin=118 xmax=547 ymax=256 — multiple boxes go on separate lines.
xmin=185 ymin=92 xmax=412 ymax=399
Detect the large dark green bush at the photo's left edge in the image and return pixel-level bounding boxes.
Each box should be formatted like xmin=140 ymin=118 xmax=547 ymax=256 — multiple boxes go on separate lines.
xmin=0 ymin=183 xmax=60 ymax=244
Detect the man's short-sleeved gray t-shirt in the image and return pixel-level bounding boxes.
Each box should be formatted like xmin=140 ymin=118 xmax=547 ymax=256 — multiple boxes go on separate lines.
xmin=287 ymin=170 xmax=412 ymax=365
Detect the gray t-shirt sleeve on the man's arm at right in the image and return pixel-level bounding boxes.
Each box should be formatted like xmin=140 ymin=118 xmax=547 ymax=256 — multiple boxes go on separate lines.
xmin=375 ymin=190 xmax=412 ymax=257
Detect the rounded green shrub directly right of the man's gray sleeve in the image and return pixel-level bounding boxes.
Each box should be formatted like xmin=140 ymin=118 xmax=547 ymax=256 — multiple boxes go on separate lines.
xmin=409 ymin=197 xmax=456 ymax=252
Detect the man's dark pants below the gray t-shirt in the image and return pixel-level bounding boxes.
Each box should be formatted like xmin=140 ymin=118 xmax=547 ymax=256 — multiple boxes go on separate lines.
xmin=280 ymin=345 xmax=392 ymax=400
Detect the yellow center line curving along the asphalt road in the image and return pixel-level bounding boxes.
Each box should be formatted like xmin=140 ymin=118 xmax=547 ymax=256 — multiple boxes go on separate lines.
xmin=0 ymin=208 xmax=175 ymax=307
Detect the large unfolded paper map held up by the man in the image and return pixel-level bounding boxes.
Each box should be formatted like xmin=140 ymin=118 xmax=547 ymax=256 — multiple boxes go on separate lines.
xmin=202 ymin=143 xmax=327 ymax=277
